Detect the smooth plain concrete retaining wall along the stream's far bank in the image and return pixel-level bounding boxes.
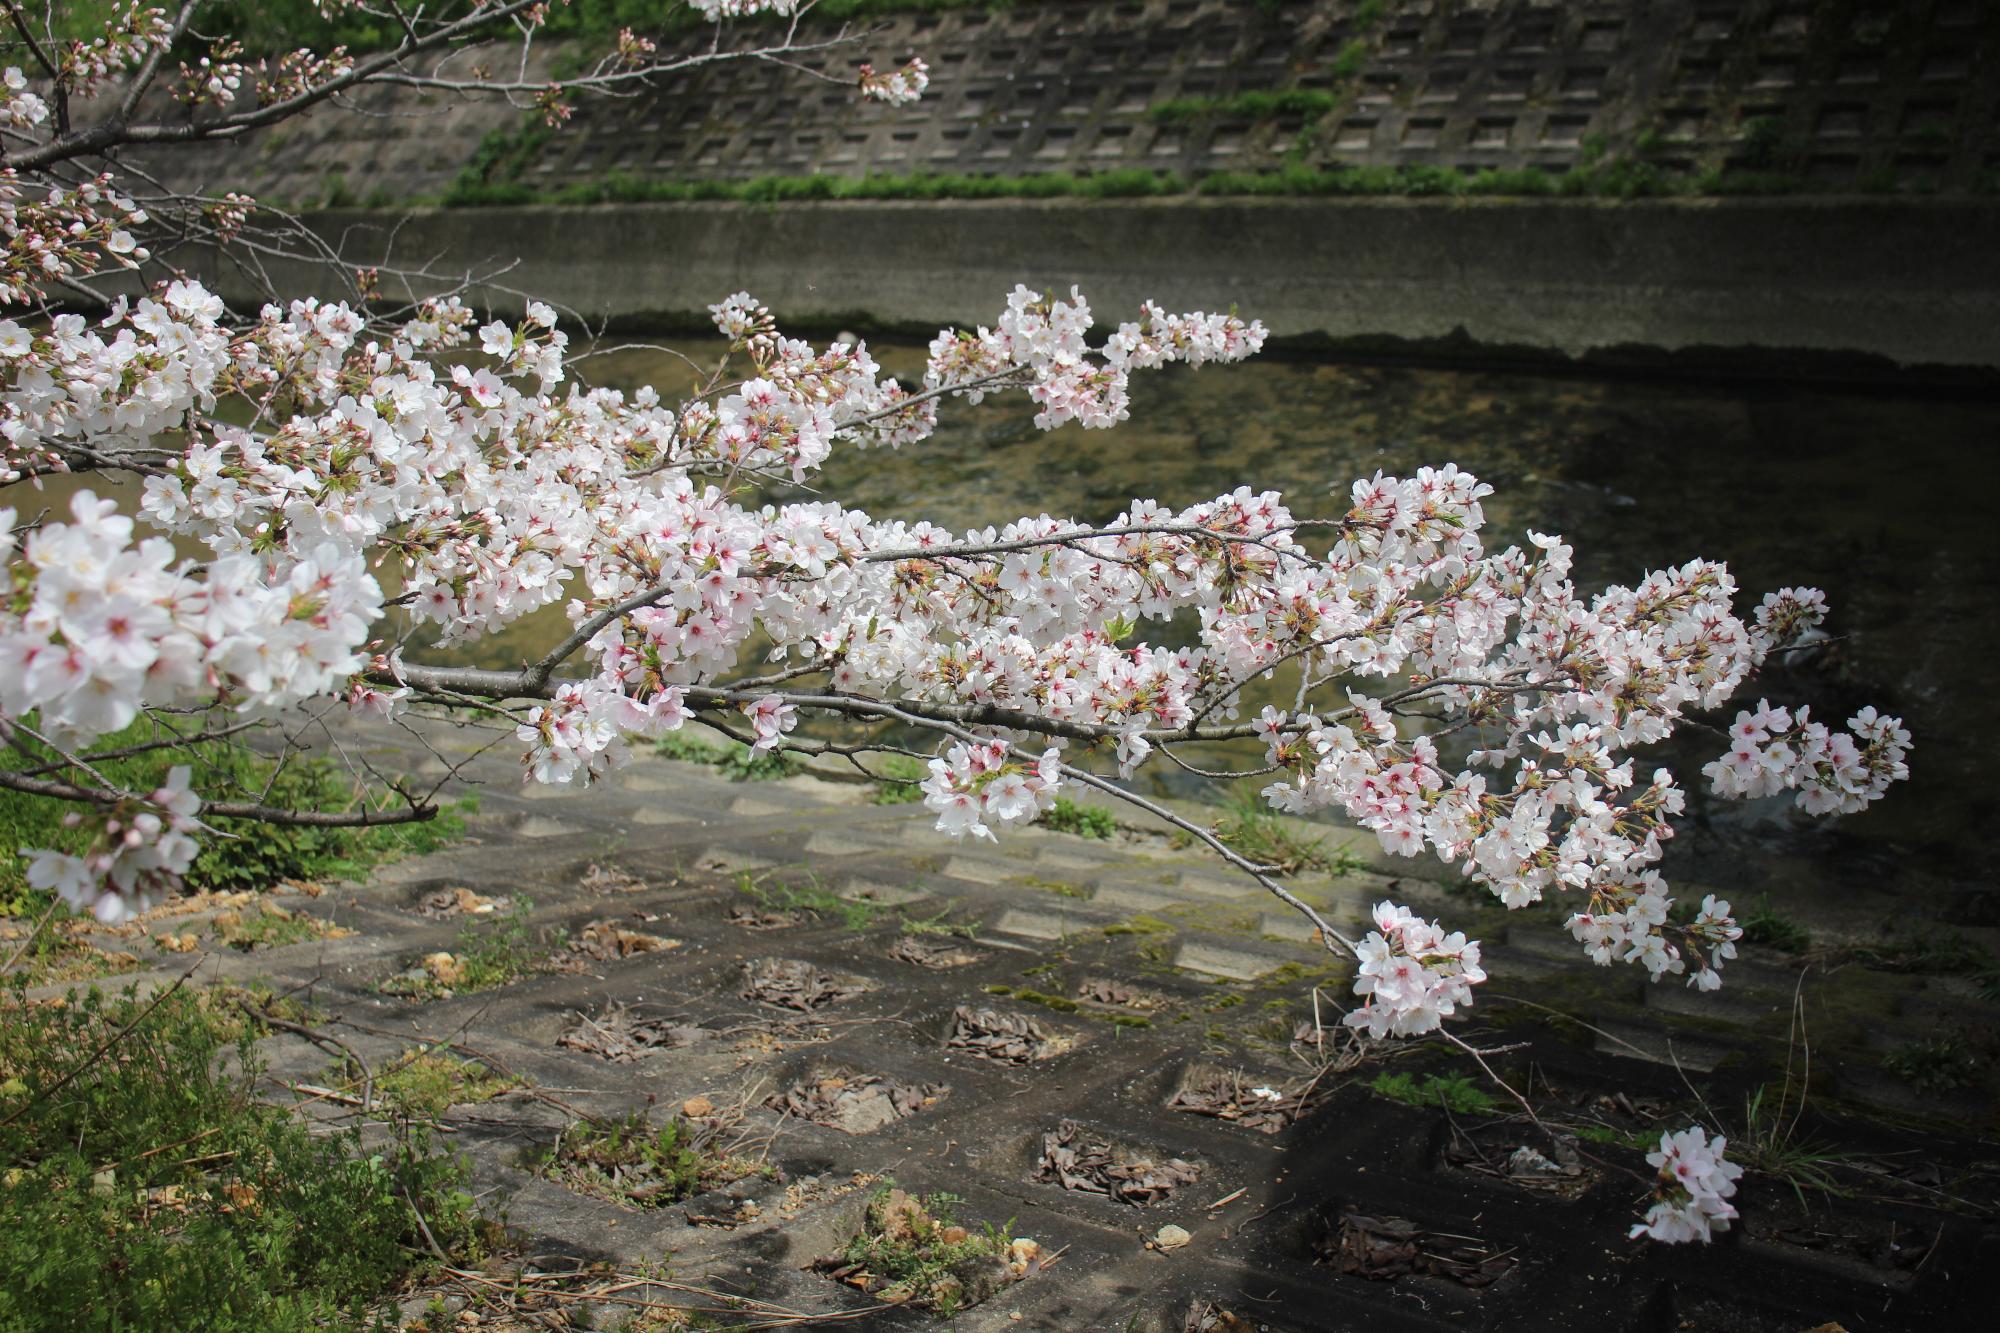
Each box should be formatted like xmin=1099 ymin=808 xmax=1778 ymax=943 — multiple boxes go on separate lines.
xmin=203 ymin=198 xmax=2000 ymax=374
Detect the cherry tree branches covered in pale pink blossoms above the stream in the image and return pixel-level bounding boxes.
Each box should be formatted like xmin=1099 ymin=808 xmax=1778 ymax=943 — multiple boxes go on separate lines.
xmin=0 ymin=0 xmax=1910 ymax=1241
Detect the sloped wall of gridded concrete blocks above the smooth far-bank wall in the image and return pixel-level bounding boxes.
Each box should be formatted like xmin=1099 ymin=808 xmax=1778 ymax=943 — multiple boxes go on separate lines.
xmin=129 ymin=0 xmax=2000 ymax=202
